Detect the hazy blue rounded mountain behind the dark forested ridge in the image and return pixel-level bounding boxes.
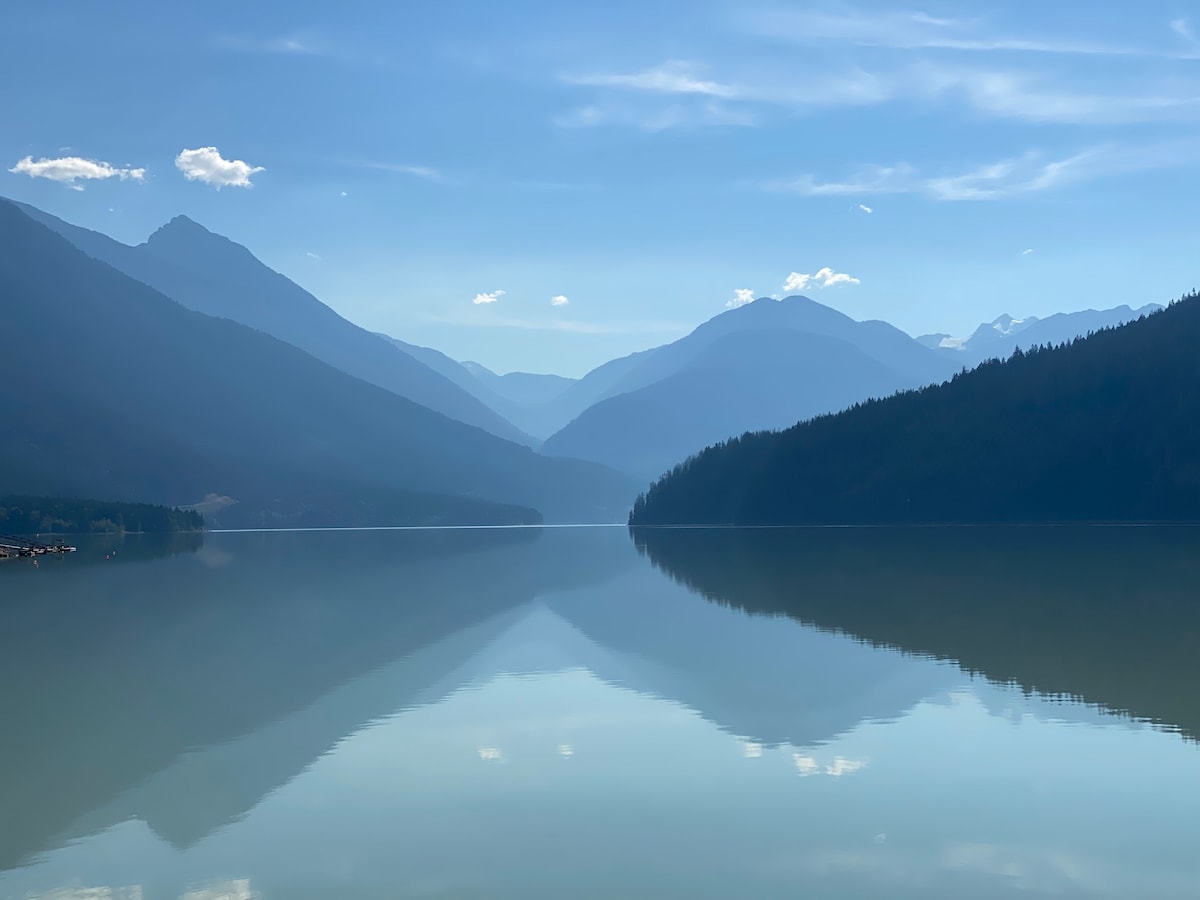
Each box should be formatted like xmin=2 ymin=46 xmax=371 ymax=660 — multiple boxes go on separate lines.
xmin=544 ymin=296 xmax=954 ymax=478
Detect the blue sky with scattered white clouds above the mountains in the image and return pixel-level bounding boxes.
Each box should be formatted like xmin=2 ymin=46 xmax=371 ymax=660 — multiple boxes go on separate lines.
xmin=0 ymin=0 xmax=1200 ymax=376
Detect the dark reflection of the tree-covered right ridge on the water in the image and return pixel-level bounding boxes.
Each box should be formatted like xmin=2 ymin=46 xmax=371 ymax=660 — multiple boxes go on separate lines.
xmin=635 ymin=527 xmax=1200 ymax=738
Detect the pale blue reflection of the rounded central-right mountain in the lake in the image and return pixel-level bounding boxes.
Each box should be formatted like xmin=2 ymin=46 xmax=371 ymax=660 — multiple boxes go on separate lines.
xmin=547 ymin=568 xmax=964 ymax=746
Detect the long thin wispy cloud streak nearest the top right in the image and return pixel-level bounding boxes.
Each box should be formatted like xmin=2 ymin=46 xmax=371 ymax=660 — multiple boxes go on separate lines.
xmin=739 ymin=8 xmax=1141 ymax=55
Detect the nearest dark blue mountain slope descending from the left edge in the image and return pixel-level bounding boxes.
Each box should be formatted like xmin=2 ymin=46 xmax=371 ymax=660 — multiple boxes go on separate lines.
xmin=0 ymin=202 xmax=632 ymax=524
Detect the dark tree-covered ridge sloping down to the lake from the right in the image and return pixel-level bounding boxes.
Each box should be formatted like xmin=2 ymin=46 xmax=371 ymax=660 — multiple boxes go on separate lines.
xmin=631 ymin=295 xmax=1200 ymax=524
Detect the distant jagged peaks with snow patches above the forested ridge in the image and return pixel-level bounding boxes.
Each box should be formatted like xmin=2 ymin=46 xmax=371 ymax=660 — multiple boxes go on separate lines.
xmin=917 ymin=304 xmax=1163 ymax=368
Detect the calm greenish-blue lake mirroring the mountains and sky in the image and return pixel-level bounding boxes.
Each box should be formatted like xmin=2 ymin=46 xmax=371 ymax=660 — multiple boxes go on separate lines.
xmin=0 ymin=528 xmax=1200 ymax=900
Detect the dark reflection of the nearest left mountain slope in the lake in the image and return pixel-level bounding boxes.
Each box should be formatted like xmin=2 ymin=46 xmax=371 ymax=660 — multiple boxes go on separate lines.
xmin=0 ymin=529 xmax=629 ymax=869
